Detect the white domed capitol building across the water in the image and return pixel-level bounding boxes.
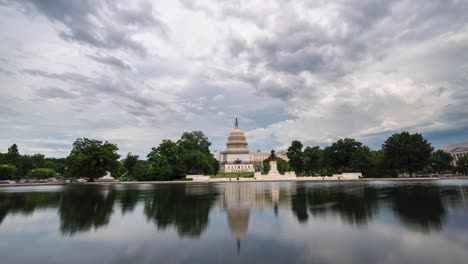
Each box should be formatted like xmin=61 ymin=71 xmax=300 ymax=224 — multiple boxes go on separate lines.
xmin=213 ymin=118 xmax=288 ymax=173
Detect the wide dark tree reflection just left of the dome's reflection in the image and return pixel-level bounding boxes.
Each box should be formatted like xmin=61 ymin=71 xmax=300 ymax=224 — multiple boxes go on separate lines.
xmin=144 ymin=184 xmax=216 ymax=237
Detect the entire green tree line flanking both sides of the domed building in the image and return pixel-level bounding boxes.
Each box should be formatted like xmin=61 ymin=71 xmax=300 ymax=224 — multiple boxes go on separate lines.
xmin=0 ymin=131 xmax=468 ymax=181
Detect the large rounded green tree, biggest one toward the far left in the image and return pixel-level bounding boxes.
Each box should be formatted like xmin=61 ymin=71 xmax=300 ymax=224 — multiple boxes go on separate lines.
xmin=66 ymin=138 xmax=120 ymax=181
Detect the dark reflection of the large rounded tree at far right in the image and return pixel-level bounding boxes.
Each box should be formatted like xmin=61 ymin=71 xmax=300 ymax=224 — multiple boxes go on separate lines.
xmin=391 ymin=185 xmax=446 ymax=232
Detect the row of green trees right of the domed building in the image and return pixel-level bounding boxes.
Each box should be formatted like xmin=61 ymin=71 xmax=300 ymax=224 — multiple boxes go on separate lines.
xmin=287 ymin=132 xmax=468 ymax=178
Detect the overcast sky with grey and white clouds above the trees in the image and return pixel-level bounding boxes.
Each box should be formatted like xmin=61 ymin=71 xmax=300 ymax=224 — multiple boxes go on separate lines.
xmin=0 ymin=0 xmax=468 ymax=157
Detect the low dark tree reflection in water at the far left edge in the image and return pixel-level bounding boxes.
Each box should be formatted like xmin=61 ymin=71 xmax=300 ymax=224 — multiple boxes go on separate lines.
xmin=0 ymin=192 xmax=60 ymax=224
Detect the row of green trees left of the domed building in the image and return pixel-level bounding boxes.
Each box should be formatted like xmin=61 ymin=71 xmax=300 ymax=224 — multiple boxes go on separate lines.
xmin=0 ymin=131 xmax=219 ymax=181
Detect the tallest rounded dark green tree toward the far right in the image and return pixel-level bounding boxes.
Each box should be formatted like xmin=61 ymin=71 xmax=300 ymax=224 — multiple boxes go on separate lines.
xmin=382 ymin=132 xmax=433 ymax=177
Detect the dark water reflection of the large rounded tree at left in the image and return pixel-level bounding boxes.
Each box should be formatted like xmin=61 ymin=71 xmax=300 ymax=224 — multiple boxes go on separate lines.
xmin=59 ymin=186 xmax=115 ymax=235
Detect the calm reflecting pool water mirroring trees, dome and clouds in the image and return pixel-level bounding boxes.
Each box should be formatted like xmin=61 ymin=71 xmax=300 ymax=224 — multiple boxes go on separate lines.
xmin=0 ymin=180 xmax=468 ymax=264
